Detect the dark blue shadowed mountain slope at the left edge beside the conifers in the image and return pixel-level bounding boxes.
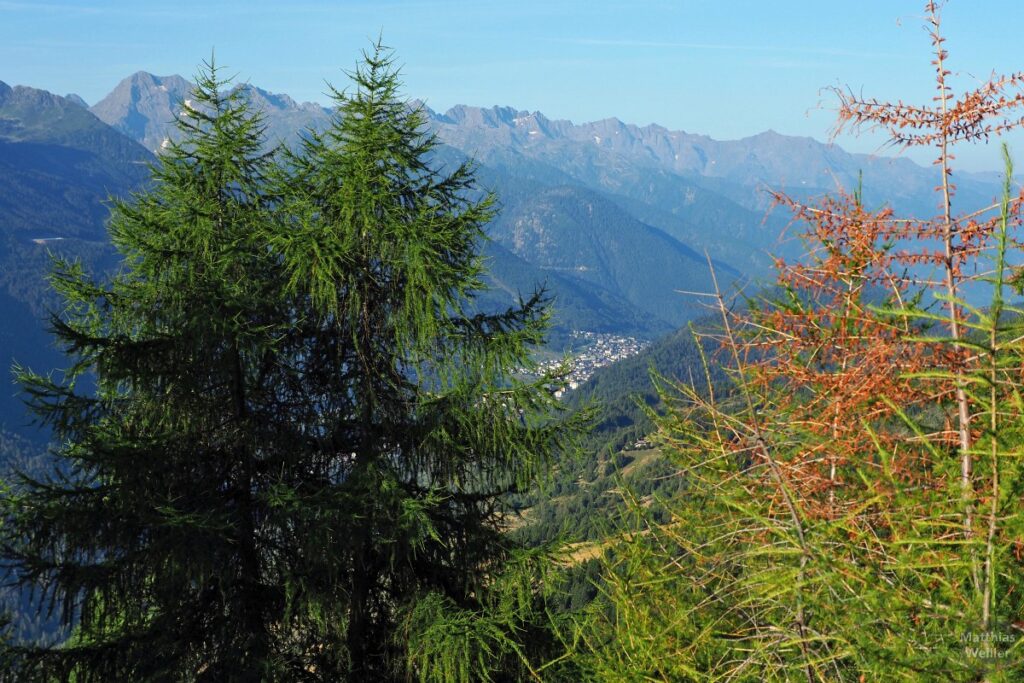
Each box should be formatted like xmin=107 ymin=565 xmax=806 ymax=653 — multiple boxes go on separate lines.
xmin=0 ymin=83 xmax=154 ymax=442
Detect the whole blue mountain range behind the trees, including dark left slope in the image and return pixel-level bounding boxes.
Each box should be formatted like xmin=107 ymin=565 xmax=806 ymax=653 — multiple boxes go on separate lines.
xmin=0 ymin=72 xmax=997 ymax=440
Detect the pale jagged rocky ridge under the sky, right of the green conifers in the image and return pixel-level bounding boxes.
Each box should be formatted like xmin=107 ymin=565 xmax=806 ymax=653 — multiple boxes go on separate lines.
xmin=423 ymin=105 xmax=992 ymax=212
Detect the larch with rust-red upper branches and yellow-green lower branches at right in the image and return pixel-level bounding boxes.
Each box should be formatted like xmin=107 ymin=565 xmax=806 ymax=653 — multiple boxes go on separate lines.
xmin=581 ymin=0 xmax=1024 ymax=683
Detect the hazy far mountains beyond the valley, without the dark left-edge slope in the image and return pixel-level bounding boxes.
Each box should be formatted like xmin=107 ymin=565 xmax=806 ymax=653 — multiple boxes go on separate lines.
xmin=77 ymin=72 xmax=996 ymax=323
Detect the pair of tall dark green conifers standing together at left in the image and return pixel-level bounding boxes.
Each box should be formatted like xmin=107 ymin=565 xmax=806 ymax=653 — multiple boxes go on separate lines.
xmin=2 ymin=45 xmax=573 ymax=682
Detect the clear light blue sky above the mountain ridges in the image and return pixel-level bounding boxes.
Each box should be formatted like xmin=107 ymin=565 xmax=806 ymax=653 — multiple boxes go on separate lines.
xmin=0 ymin=0 xmax=1024 ymax=170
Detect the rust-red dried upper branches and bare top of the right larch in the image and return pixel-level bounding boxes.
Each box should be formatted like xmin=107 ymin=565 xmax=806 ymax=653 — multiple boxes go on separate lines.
xmin=728 ymin=0 xmax=1024 ymax=520
